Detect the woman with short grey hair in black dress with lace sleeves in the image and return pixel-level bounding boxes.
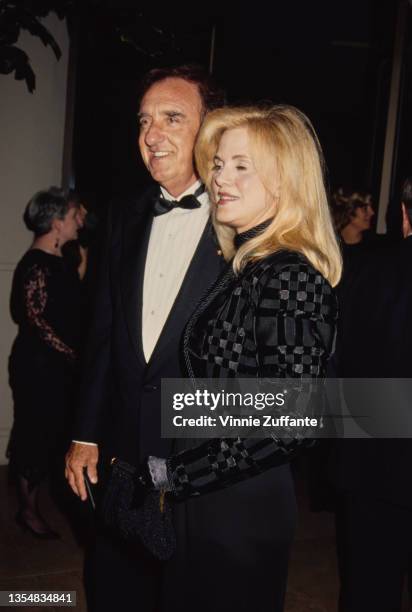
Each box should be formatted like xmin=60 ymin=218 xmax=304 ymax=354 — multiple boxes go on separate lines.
xmin=8 ymin=187 xmax=82 ymax=539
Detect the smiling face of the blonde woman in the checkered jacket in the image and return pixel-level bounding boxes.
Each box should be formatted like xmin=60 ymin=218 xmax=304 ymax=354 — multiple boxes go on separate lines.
xmin=212 ymin=127 xmax=278 ymax=233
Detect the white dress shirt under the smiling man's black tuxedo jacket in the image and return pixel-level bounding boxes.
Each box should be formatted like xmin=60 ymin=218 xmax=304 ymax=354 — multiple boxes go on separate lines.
xmin=143 ymin=181 xmax=210 ymax=361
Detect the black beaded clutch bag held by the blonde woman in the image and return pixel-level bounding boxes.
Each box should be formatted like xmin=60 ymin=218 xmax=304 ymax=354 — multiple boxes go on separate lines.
xmin=100 ymin=459 xmax=176 ymax=561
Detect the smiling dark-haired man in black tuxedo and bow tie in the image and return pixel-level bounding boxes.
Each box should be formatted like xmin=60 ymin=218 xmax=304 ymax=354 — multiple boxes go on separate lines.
xmin=66 ymin=66 xmax=222 ymax=612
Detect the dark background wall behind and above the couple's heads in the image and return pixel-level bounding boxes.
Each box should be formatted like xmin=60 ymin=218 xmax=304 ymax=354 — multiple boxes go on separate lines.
xmin=73 ymin=0 xmax=412 ymax=233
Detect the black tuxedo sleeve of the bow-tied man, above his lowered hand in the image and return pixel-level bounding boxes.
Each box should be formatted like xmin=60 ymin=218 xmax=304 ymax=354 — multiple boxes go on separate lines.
xmin=73 ymin=208 xmax=113 ymax=443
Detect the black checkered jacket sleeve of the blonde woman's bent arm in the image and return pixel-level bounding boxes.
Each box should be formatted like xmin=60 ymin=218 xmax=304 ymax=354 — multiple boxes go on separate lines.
xmin=167 ymin=264 xmax=335 ymax=499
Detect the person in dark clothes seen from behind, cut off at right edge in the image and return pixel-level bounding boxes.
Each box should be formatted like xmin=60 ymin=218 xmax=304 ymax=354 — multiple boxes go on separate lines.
xmin=332 ymin=175 xmax=412 ymax=612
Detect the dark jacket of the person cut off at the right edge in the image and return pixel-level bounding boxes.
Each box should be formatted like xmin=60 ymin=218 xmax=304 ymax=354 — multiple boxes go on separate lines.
xmin=330 ymin=237 xmax=412 ymax=509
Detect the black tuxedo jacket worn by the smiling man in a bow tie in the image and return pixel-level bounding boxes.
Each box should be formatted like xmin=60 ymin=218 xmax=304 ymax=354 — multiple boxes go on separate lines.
xmin=73 ymin=185 xmax=222 ymax=464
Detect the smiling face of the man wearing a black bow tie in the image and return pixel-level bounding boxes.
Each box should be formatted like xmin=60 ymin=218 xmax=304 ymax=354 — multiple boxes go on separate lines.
xmin=139 ymin=78 xmax=202 ymax=197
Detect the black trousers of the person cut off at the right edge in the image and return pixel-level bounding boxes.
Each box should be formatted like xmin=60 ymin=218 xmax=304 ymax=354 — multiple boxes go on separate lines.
xmin=336 ymin=494 xmax=412 ymax=612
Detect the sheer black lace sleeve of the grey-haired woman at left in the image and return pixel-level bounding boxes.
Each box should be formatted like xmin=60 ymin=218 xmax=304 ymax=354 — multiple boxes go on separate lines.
xmin=24 ymin=265 xmax=76 ymax=359
